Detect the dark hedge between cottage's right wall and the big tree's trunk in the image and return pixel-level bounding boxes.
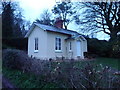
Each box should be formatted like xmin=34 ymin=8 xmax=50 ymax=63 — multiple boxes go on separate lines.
xmin=87 ymin=38 xmax=112 ymax=57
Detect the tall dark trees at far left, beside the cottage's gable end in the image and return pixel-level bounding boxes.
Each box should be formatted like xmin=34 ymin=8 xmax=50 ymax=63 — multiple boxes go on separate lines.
xmin=2 ymin=2 xmax=27 ymax=51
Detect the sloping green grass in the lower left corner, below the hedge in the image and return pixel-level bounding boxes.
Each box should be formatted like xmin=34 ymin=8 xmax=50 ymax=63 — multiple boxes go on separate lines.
xmin=3 ymin=67 xmax=57 ymax=89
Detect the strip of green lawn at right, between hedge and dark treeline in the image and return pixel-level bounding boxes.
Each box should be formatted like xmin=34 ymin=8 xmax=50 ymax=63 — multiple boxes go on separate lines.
xmin=94 ymin=58 xmax=120 ymax=70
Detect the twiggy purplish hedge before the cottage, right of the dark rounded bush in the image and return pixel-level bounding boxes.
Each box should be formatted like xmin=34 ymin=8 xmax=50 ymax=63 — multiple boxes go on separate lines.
xmin=27 ymin=60 xmax=120 ymax=89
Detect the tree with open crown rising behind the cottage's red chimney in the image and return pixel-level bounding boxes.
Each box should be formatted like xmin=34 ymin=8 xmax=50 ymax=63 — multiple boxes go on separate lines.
xmin=52 ymin=2 xmax=76 ymax=29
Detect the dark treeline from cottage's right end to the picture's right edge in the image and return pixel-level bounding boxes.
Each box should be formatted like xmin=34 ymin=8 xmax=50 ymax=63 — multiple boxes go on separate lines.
xmin=87 ymin=37 xmax=120 ymax=58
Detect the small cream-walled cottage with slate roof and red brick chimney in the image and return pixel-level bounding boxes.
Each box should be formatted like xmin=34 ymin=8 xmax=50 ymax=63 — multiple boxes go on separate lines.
xmin=25 ymin=19 xmax=87 ymax=59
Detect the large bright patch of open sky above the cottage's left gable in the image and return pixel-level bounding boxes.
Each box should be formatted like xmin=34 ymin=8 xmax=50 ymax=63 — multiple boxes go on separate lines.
xmin=19 ymin=0 xmax=55 ymax=21
